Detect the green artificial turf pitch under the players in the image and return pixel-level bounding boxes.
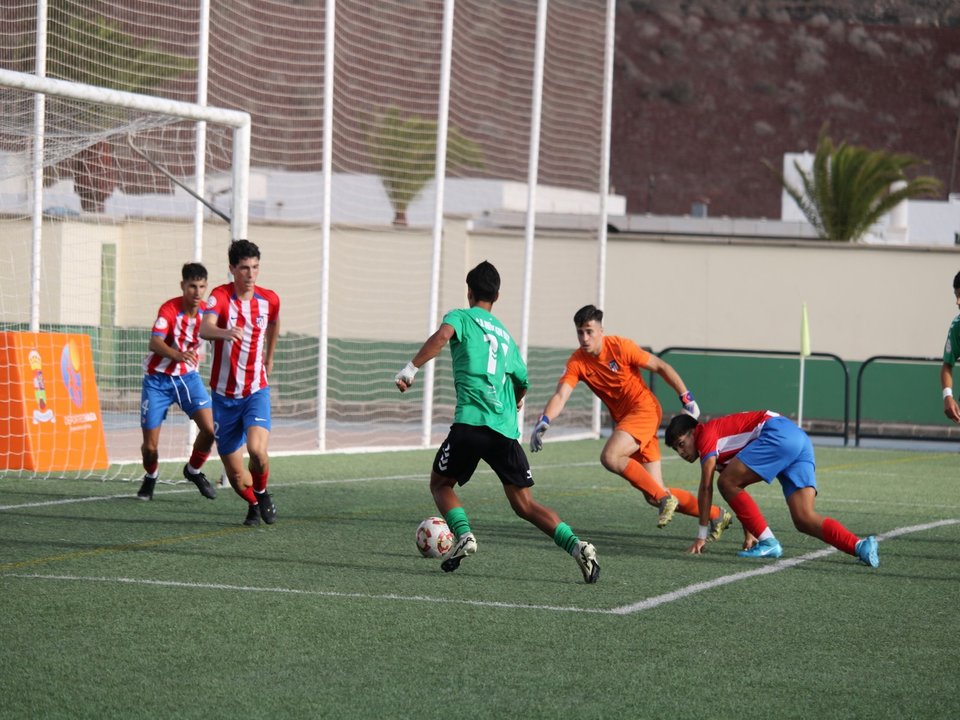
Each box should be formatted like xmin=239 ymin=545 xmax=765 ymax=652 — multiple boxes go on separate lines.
xmin=0 ymin=441 xmax=960 ymax=720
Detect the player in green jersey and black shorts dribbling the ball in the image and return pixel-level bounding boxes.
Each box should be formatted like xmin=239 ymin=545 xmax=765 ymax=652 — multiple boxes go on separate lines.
xmin=395 ymin=260 xmax=600 ymax=583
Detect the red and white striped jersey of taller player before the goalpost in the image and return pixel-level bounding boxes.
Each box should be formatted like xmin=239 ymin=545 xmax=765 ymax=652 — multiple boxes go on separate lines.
xmin=206 ymin=283 xmax=280 ymax=398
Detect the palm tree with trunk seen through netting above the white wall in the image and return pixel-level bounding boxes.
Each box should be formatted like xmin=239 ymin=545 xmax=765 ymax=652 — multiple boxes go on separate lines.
xmin=367 ymin=107 xmax=483 ymax=225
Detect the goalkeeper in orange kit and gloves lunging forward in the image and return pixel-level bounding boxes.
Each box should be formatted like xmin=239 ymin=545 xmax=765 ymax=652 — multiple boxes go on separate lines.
xmin=530 ymin=305 xmax=733 ymax=540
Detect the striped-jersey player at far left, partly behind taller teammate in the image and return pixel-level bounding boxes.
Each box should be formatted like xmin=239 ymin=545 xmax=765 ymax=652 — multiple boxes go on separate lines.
xmin=137 ymin=263 xmax=217 ymax=500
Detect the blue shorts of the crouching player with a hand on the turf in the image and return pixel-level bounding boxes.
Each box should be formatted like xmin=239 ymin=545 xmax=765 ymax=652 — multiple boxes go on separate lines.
xmin=737 ymin=416 xmax=817 ymax=498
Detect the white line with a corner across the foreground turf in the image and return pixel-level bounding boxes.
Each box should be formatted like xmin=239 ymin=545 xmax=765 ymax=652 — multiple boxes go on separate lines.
xmin=0 ymin=518 xmax=960 ymax=615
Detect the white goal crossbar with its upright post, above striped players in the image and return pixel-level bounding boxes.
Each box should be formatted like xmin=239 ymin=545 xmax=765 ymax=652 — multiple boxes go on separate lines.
xmin=0 ymin=68 xmax=251 ymax=239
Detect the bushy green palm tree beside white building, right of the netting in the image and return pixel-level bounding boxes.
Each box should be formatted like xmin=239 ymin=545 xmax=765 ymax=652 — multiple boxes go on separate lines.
xmin=767 ymin=125 xmax=941 ymax=242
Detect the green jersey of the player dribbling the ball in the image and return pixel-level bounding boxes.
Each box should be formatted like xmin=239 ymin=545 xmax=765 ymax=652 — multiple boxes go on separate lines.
xmin=443 ymin=307 xmax=529 ymax=439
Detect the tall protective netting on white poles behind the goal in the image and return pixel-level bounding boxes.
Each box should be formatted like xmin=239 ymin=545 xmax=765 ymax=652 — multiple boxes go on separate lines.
xmin=0 ymin=0 xmax=610 ymax=484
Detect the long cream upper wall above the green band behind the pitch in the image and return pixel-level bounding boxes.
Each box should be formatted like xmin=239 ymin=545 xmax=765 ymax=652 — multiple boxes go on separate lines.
xmin=0 ymin=218 xmax=960 ymax=360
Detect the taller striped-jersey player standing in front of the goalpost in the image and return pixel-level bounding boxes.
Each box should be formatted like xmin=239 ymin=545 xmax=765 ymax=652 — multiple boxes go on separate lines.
xmin=200 ymin=240 xmax=280 ymax=527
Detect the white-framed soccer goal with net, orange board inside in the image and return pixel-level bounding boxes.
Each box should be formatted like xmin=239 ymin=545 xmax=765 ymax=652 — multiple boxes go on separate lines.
xmin=0 ymin=70 xmax=250 ymax=477
